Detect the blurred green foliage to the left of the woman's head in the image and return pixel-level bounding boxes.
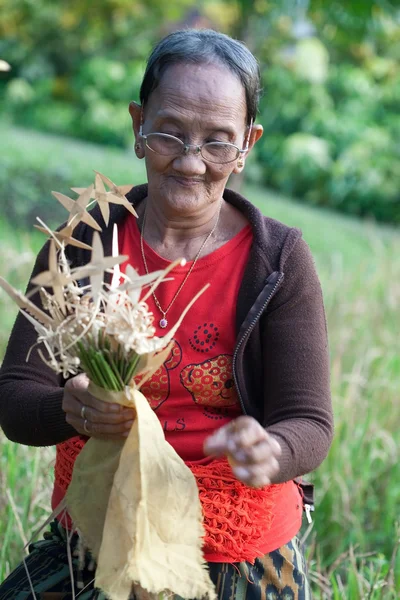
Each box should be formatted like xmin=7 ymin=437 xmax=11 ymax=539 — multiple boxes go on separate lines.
xmin=0 ymin=0 xmax=192 ymax=145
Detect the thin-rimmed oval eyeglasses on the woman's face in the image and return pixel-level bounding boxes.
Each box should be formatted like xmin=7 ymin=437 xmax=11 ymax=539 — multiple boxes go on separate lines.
xmin=139 ymin=125 xmax=251 ymax=165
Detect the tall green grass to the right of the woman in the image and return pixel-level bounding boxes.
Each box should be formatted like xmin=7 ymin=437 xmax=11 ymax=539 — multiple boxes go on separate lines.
xmin=246 ymin=182 xmax=400 ymax=600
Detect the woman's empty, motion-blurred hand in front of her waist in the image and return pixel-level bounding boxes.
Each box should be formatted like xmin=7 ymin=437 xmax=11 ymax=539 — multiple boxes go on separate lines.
xmin=204 ymin=415 xmax=282 ymax=487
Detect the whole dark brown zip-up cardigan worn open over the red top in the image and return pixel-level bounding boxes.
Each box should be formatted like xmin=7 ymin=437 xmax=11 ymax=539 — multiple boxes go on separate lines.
xmin=0 ymin=185 xmax=333 ymax=481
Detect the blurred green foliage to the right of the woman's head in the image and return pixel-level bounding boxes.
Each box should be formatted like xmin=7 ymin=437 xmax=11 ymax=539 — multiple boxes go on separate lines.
xmin=223 ymin=0 xmax=400 ymax=224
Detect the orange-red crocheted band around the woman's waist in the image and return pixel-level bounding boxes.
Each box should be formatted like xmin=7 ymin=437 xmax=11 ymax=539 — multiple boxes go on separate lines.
xmin=55 ymin=437 xmax=285 ymax=562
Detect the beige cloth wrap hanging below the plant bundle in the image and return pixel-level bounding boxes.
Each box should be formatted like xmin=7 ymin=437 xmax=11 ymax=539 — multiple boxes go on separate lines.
xmin=66 ymin=383 xmax=216 ymax=600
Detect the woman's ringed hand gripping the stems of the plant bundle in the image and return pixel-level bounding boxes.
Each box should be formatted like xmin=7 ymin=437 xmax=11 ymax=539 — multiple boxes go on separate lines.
xmin=62 ymin=373 xmax=136 ymax=440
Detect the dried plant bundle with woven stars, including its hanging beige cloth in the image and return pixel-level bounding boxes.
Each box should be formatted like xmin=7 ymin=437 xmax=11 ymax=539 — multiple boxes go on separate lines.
xmin=0 ymin=172 xmax=215 ymax=600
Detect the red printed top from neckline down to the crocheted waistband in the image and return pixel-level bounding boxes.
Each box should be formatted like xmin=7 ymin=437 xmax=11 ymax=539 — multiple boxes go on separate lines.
xmin=120 ymin=217 xmax=252 ymax=461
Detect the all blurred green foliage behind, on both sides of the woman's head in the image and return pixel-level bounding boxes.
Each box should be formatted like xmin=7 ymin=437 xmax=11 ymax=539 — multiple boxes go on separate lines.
xmin=0 ymin=0 xmax=400 ymax=224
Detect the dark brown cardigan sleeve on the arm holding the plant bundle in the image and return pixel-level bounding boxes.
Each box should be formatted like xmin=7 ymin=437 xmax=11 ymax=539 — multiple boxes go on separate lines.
xmin=0 ymin=244 xmax=77 ymax=446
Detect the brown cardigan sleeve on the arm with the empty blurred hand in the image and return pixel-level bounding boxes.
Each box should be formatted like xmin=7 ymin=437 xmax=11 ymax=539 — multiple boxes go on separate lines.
xmin=261 ymin=239 xmax=333 ymax=481
